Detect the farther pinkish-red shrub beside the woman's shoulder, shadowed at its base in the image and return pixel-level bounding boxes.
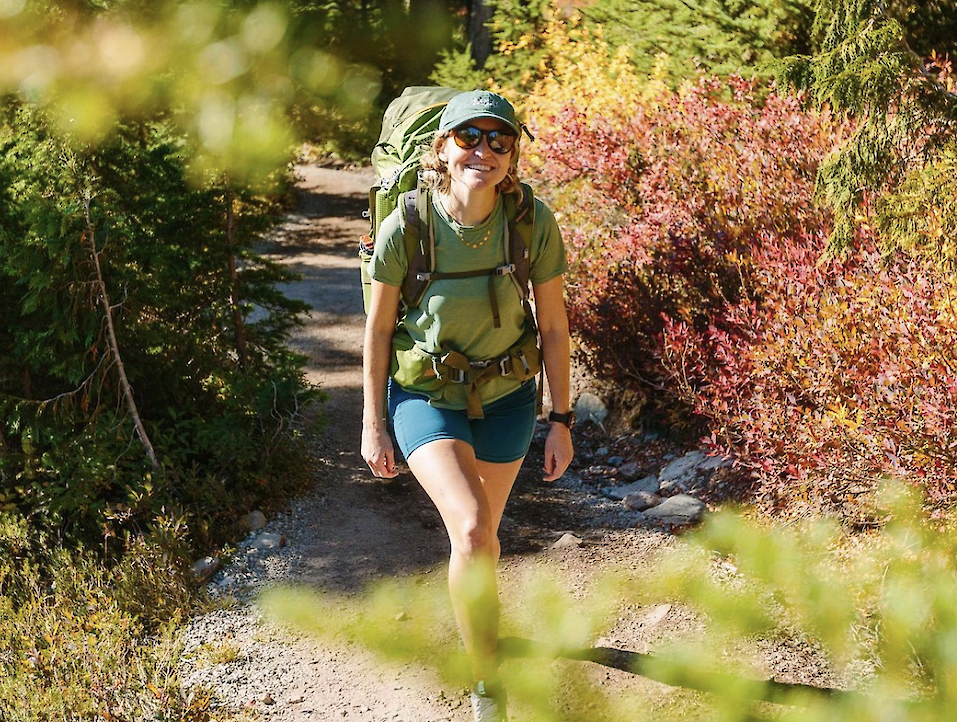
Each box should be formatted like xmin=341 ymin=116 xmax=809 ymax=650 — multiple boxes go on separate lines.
xmin=540 ymin=79 xmax=835 ymax=424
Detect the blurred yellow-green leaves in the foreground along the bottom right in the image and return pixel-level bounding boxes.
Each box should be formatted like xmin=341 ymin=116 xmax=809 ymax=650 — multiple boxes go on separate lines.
xmin=262 ymin=484 xmax=957 ymax=722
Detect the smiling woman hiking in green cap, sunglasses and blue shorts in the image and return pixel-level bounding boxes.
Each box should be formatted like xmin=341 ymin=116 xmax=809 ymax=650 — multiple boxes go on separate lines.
xmin=362 ymin=91 xmax=574 ymax=722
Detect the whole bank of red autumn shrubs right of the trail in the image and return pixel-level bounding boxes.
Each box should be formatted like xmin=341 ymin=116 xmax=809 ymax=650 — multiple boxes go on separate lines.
xmin=542 ymin=74 xmax=957 ymax=522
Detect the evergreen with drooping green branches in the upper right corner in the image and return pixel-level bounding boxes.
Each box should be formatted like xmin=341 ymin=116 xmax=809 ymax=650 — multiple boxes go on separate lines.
xmin=780 ymin=0 xmax=957 ymax=258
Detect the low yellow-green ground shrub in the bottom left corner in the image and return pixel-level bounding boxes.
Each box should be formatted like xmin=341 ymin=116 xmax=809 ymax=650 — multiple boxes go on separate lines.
xmin=0 ymin=551 xmax=230 ymax=722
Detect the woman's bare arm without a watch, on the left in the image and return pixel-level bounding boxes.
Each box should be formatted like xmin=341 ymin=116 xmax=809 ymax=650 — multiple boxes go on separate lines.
xmin=361 ymin=281 xmax=399 ymax=478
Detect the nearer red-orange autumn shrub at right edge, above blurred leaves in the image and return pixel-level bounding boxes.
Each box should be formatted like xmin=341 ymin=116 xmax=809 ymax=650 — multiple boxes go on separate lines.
xmin=665 ymin=241 xmax=957 ymax=521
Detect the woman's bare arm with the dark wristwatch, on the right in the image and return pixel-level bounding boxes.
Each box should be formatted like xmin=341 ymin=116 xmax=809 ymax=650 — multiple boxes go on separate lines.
xmin=534 ymin=276 xmax=575 ymax=481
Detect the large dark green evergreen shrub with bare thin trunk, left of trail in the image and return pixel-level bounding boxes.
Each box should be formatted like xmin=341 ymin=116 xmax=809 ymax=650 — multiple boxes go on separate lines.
xmin=0 ymin=105 xmax=318 ymax=547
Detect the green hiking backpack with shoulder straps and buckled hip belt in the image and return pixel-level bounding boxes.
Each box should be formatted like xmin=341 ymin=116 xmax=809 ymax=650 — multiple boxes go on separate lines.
xmin=359 ymin=86 xmax=542 ymax=418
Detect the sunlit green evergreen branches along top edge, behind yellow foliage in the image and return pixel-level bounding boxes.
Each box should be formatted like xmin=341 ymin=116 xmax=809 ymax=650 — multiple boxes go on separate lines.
xmin=433 ymin=0 xmax=813 ymax=100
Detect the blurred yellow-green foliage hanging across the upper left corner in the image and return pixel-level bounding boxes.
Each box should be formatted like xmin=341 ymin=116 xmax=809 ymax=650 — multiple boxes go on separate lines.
xmin=0 ymin=0 xmax=380 ymax=179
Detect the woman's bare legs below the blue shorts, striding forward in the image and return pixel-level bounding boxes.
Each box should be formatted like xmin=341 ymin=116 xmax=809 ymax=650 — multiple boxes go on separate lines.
xmin=408 ymin=439 xmax=522 ymax=681
